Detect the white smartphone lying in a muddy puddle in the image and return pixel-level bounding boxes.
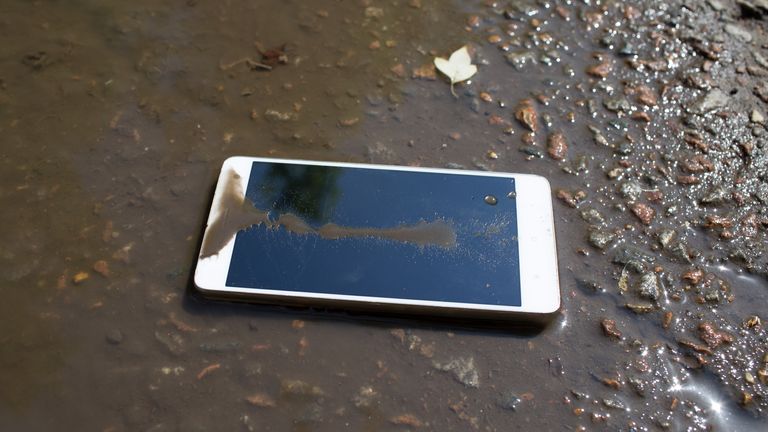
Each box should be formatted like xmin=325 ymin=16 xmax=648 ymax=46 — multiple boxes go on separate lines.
xmin=194 ymin=157 xmax=560 ymax=322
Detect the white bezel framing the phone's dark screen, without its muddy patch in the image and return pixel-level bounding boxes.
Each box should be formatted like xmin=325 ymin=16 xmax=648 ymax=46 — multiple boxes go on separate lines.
xmin=194 ymin=156 xmax=560 ymax=314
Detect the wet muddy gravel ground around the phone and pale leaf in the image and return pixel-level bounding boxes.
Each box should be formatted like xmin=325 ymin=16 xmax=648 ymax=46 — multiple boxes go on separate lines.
xmin=0 ymin=0 xmax=768 ymax=432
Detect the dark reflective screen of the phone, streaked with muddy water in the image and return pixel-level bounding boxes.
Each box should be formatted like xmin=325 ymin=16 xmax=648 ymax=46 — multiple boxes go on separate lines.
xmin=227 ymin=162 xmax=521 ymax=306
